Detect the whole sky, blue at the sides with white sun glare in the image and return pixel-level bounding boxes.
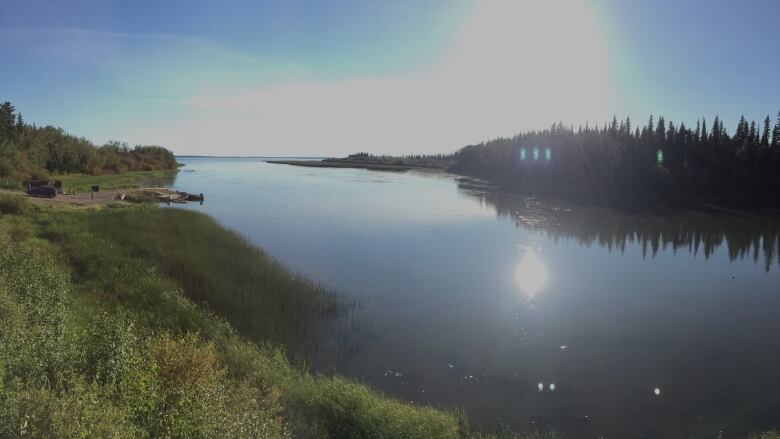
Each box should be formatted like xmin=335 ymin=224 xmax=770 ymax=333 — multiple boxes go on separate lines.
xmin=0 ymin=0 xmax=780 ymax=156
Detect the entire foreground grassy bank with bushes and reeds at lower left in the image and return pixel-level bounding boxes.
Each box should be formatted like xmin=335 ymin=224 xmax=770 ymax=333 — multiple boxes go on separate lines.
xmin=0 ymin=197 xmax=560 ymax=438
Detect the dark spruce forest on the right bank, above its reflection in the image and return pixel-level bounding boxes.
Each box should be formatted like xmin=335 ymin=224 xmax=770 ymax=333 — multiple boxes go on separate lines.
xmin=450 ymin=113 xmax=780 ymax=203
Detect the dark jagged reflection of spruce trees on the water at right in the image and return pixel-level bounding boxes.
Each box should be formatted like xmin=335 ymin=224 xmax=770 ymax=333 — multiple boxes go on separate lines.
xmin=458 ymin=179 xmax=780 ymax=272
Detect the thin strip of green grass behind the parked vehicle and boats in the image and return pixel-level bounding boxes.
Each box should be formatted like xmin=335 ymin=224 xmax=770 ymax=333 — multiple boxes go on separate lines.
xmin=49 ymin=170 xmax=177 ymax=192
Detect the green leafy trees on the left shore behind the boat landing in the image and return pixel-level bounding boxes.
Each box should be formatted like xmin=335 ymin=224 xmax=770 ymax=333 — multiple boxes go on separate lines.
xmin=0 ymin=102 xmax=177 ymax=184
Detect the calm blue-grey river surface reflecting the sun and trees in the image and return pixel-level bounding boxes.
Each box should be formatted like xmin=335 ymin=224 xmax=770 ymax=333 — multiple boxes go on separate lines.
xmin=175 ymin=158 xmax=780 ymax=437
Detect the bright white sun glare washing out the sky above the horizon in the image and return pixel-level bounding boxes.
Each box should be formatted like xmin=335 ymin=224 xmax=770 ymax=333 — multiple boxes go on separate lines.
xmin=135 ymin=0 xmax=615 ymax=156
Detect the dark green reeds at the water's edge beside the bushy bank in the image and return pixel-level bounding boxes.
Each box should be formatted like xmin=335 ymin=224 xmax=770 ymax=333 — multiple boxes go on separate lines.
xmin=43 ymin=208 xmax=342 ymax=355
